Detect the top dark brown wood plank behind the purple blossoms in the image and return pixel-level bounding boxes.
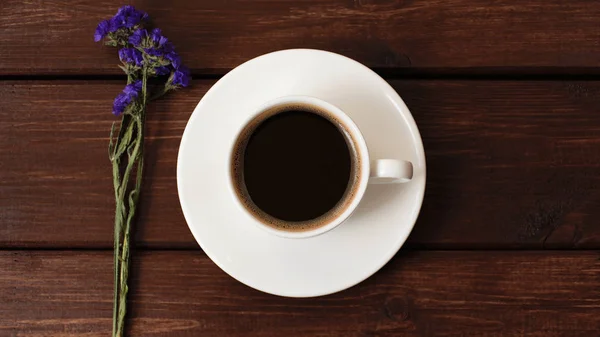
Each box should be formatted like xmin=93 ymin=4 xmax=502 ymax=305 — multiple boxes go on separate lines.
xmin=0 ymin=0 xmax=600 ymax=75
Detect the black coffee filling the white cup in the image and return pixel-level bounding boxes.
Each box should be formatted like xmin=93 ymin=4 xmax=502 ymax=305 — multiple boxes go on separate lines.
xmin=233 ymin=107 xmax=357 ymax=230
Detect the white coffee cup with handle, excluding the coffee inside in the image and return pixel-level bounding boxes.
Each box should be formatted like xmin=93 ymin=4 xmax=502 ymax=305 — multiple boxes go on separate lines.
xmin=230 ymin=96 xmax=413 ymax=239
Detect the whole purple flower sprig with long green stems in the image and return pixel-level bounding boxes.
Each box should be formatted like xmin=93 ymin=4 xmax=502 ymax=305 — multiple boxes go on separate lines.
xmin=95 ymin=5 xmax=190 ymax=337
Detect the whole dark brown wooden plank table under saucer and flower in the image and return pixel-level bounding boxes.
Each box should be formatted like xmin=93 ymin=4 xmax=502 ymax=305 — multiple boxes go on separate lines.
xmin=0 ymin=0 xmax=600 ymax=337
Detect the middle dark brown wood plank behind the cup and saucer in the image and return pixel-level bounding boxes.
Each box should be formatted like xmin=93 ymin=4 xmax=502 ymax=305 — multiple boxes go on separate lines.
xmin=0 ymin=80 xmax=600 ymax=249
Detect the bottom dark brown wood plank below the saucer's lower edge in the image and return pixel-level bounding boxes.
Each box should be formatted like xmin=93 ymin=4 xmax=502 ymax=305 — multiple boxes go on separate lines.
xmin=0 ymin=251 xmax=600 ymax=337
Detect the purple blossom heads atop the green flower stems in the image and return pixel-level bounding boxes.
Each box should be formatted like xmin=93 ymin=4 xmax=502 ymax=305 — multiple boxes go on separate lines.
xmin=94 ymin=6 xmax=190 ymax=116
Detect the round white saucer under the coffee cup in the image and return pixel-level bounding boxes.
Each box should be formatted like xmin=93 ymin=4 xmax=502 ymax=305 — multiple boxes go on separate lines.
xmin=177 ymin=49 xmax=425 ymax=297
